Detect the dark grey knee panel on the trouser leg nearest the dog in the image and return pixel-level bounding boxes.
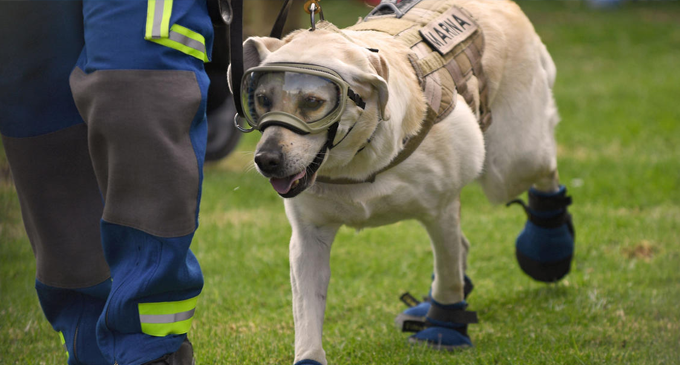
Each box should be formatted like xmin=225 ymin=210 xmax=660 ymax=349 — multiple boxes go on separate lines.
xmin=70 ymin=68 xmax=205 ymax=237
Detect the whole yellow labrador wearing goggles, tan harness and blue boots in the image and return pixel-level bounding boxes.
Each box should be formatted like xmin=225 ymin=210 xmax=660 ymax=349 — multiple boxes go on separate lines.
xmin=234 ymin=0 xmax=573 ymax=364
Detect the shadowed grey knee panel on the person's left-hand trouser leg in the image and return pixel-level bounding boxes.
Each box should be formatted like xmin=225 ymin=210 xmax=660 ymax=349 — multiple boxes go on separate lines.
xmin=2 ymin=123 xmax=109 ymax=288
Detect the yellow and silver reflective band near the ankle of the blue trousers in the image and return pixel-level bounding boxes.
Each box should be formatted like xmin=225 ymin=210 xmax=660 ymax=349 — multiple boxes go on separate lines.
xmin=138 ymin=296 xmax=198 ymax=337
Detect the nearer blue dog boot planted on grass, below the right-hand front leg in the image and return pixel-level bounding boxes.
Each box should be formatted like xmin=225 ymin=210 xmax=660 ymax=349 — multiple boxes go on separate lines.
xmin=409 ymin=299 xmax=479 ymax=351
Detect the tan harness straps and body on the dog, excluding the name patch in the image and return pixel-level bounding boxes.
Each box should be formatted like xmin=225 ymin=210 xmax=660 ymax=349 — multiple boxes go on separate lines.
xmin=317 ymin=0 xmax=492 ymax=185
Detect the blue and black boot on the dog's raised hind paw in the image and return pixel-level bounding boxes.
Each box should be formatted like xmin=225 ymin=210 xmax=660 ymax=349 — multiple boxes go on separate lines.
xmin=507 ymin=186 xmax=574 ymax=283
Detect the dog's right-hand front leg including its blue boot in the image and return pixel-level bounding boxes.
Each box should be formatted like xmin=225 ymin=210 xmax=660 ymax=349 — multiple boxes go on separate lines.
xmin=409 ymin=199 xmax=477 ymax=350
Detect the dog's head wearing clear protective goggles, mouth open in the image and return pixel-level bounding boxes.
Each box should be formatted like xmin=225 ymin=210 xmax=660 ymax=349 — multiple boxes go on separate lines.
xmin=236 ymin=26 xmax=388 ymax=198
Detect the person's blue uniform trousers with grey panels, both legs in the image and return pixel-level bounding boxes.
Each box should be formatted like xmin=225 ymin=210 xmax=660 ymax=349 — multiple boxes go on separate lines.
xmin=0 ymin=0 xmax=213 ymax=365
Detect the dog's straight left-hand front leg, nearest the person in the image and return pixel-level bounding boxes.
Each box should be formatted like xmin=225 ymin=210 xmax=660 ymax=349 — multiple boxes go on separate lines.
xmin=290 ymin=219 xmax=339 ymax=365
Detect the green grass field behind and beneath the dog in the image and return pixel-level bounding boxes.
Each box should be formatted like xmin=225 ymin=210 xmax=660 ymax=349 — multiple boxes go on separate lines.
xmin=0 ymin=1 xmax=680 ymax=365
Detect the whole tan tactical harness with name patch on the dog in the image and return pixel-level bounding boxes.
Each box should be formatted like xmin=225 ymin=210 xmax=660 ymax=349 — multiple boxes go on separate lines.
xmin=317 ymin=0 xmax=492 ymax=184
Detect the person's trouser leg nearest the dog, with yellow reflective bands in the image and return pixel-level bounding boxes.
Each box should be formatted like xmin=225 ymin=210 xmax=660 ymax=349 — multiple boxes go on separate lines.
xmin=70 ymin=0 xmax=212 ymax=365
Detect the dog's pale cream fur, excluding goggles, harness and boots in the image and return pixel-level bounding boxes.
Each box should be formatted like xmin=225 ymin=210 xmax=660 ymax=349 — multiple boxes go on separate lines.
xmin=244 ymin=0 xmax=559 ymax=364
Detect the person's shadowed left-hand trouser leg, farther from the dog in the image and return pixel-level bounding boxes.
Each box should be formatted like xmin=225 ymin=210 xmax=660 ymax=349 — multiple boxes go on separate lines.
xmin=0 ymin=1 xmax=111 ymax=365
